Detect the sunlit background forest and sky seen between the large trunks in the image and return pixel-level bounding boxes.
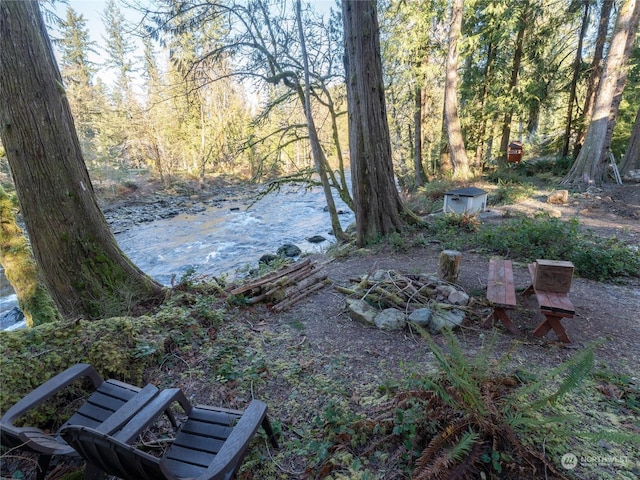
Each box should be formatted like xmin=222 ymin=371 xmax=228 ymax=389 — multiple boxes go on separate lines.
xmin=10 ymin=0 xmax=640 ymax=188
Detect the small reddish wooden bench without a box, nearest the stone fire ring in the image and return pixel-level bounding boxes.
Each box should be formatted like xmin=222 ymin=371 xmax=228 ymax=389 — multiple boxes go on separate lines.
xmin=482 ymin=258 xmax=518 ymax=334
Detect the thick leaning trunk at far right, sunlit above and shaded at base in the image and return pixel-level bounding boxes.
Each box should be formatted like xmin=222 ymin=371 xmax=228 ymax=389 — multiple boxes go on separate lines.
xmin=562 ymin=0 xmax=640 ymax=185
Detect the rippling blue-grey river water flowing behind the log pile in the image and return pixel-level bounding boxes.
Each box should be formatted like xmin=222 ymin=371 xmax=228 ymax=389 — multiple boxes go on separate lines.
xmin=0 ymin=187 xmax=354 ymax=329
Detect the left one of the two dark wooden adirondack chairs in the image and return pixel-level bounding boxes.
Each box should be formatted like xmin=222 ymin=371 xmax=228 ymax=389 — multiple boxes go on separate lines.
xmin=0 ymin=363 xmax=158 ymax=480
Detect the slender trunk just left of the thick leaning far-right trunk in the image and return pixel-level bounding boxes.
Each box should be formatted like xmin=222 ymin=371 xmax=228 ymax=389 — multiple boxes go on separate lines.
xmin=573 ymin=0 xmax=614 ymax=159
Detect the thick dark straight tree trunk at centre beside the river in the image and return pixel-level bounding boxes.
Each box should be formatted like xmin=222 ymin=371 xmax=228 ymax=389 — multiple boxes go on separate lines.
xmin=342 ymin=0 xmax=405 ymax=246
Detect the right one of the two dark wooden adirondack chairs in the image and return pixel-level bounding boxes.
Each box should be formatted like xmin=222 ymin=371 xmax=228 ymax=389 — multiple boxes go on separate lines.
xmin=61 ymin=400 xmax=278 ymax=480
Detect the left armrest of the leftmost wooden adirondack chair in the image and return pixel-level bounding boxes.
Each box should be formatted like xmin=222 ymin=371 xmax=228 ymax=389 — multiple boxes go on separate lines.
xmin=0 ymin=363 xmax=104 ymax=429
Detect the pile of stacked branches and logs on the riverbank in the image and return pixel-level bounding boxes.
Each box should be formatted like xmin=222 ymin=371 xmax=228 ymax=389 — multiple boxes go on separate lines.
xmin=231 ymin=259 xmax=327 ymax=312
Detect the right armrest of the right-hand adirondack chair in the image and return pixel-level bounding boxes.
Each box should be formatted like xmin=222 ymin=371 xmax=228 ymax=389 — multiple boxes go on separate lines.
xmin=179 ymin=400 xmax=267 ymax=480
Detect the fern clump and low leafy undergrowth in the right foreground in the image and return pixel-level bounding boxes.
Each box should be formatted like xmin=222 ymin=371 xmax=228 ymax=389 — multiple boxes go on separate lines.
xmin=308 ymin=333 xmax=612 ymax=480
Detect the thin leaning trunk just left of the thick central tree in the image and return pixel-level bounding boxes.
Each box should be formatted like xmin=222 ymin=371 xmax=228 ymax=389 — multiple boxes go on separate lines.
xmin=296 ymin=0 xmax=348 ymax=242
